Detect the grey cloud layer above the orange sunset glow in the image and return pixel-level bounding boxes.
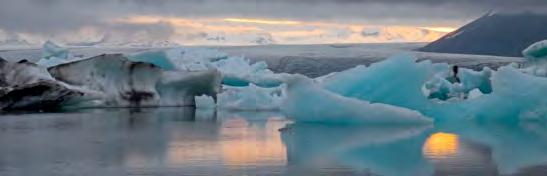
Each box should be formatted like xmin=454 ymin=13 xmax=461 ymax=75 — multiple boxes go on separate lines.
xmin=0 ymin=0 xmax=547 ymax=39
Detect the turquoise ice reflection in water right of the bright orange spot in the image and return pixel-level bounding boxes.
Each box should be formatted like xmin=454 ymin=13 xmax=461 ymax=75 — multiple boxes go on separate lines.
xmin=439 ymin=122 xmax=547 ymax=175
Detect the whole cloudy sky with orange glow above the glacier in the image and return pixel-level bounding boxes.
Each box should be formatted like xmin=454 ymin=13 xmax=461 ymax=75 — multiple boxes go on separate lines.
xmin=0 ymin=0 xmax=547 ymax=46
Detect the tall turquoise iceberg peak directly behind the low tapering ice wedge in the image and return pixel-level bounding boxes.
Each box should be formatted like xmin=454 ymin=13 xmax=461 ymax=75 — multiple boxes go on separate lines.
xmin=322 ymin=55 xmax=436 ymax=112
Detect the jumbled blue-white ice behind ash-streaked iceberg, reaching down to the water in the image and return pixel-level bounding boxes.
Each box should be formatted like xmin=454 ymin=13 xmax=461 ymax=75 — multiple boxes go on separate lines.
xmin=128 ymin=48 xmax=282 ymax=111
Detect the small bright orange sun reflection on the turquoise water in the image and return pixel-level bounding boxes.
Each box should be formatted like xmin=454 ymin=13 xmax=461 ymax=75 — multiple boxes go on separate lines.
xmin=422 ymin=132 xmax=459 ymax=159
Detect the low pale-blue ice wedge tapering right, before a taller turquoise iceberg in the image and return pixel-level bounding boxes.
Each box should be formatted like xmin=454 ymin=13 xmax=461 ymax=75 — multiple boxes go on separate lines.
xmin=281 ymin=75 xmax=432 ymax=124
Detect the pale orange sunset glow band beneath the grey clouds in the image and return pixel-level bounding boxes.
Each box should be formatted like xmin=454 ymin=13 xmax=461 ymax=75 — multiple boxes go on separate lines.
xmin=106 ymin=16 xmax=454 ymax=45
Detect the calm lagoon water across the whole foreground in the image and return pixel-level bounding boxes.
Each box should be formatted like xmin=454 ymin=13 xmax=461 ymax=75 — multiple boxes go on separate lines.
xmin=0 ymin=108 xmax=547 ymax=176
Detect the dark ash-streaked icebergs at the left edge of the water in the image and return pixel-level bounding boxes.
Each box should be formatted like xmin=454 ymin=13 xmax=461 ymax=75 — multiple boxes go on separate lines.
xmin=0 ymin=54 xmax=221 ymax=110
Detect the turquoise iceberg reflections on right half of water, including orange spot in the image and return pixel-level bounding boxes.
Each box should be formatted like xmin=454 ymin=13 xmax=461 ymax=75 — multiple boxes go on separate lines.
xmin=282 ymin=122 xmax=547 ymax=175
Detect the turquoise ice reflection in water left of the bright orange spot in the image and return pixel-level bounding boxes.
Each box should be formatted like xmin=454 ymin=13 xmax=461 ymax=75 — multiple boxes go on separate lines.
xmin=282 ymin=124 xmax=433 ymax=175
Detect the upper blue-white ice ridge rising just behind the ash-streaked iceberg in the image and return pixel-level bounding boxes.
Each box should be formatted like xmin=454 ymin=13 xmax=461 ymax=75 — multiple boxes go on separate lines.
xmin=128 ymin=48 xmax=281 ymax=87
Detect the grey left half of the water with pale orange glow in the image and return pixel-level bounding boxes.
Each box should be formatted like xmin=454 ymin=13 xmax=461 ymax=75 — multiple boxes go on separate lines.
xmin=0 ymin=108 xmax=286 ymax=176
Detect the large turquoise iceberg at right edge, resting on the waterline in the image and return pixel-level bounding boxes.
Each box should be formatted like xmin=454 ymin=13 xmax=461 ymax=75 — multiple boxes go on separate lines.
xmin=462 ymin=67 xmax=547 ymax=121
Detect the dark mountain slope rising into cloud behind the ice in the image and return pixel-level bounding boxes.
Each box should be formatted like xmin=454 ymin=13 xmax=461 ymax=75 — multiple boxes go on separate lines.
xmin=418 ymin=13 xmax=547 ymax=57
